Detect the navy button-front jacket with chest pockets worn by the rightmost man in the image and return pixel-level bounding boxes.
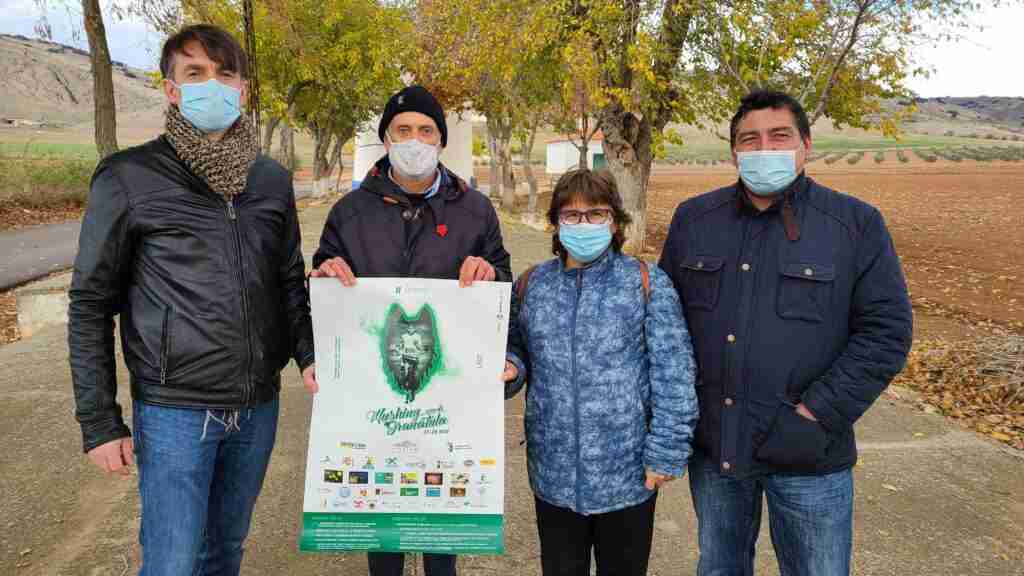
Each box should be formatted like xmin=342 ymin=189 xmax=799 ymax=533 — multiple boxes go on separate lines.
xmin=660 ymin=177 xmax=912 ymax=477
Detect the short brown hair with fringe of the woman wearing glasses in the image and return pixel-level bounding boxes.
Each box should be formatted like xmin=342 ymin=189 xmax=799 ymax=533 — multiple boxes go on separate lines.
xmin=548 ymin=168 xmax=633 ymax=256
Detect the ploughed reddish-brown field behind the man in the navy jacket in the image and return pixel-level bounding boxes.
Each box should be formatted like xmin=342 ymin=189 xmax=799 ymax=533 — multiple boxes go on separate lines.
xmin=647 ymin=155 xmax=1024 ymax=337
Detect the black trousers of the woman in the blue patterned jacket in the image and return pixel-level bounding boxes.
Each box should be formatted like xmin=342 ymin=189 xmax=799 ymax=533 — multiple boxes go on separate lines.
xmin=534 ymin=492 xmax=657 ymax=576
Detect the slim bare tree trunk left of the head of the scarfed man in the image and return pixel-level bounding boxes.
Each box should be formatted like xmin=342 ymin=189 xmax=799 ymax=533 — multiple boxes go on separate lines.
xmin=82 ymin=0 xmax=118 ymax=158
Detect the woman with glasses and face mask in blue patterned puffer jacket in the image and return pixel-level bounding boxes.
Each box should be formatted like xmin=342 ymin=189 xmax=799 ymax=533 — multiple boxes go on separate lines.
xmin=510 ymin=170 xmax=697 ymax=576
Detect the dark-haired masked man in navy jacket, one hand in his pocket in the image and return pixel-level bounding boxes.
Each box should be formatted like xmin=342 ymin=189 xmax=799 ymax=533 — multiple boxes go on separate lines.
xmin=660 ymin=91 xmax=912 ymax=576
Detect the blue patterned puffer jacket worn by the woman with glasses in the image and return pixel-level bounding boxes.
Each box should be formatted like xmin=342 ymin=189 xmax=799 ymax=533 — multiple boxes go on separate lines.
xmin=509 ymin=250 xmax=697 ymax=515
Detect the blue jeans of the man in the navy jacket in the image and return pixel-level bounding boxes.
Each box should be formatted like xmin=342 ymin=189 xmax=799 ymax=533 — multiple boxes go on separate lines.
xmin=689 ymin=455 xmax=853 ymax=576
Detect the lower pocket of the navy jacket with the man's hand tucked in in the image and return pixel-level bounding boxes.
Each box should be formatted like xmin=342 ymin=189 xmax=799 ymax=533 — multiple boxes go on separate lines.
xmin=755 ymin=403 xmax=829 ymax=472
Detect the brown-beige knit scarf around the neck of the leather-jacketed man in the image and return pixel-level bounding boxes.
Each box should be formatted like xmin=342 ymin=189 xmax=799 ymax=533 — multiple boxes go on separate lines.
xmin=166 ymin=106 xmax=259 ymax=200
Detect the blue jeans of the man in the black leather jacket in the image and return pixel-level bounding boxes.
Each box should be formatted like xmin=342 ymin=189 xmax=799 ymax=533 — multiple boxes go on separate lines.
xmin=132 ymin=399 xmax=278 ymax=576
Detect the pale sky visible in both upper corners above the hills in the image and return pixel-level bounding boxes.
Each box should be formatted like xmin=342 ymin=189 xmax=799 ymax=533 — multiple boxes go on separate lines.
xmin=0 ymin=0 xmax=1024 ymax=96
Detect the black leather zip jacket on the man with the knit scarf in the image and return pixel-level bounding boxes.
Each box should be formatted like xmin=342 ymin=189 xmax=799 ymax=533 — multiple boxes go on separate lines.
xmin=68 ymin=137 xmax=313 ymax=452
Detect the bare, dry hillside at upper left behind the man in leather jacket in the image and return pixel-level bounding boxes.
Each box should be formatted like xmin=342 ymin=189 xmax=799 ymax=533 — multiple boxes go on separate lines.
xmin=0 ymin=35 xmax=164 ymax=126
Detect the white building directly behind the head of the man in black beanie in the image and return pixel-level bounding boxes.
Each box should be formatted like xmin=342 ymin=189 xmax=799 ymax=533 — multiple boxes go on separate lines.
xmin=352 ymin=114 xmax=473 ymax=190
